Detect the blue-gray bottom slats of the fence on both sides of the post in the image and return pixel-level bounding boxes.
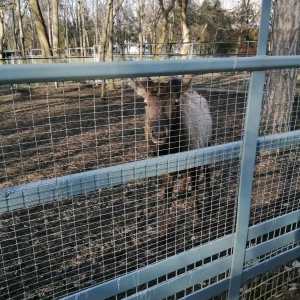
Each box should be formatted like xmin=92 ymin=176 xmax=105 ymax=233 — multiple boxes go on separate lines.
xmin=58 ymin=211 xmax=300 ymax=300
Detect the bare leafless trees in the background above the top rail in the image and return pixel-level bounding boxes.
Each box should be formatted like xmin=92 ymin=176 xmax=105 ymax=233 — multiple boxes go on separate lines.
xmin=0 ymin=0 xmax=259 ymax=60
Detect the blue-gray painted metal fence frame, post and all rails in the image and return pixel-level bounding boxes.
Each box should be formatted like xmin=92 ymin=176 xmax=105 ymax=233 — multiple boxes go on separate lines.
xmin=0 ymin=0 xmax=300 ymax=300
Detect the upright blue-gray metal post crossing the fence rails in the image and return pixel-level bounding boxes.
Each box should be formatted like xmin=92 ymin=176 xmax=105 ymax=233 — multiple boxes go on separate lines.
xmin=228 ymin=0 xmax=271 ymax=300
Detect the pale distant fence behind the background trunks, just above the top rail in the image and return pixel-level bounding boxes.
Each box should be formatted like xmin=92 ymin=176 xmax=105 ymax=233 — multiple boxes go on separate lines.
xmin=2 ymin=41 xmax=257 ymax=64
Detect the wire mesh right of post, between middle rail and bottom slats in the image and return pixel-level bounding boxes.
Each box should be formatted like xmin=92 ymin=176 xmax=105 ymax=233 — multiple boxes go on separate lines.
xmin=251 ymin=147 xmax=300 ymax=224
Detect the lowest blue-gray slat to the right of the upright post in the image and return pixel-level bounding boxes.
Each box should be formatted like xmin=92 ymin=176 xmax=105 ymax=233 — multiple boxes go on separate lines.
xmin=242 ymin=246 xmax=300 ymax=282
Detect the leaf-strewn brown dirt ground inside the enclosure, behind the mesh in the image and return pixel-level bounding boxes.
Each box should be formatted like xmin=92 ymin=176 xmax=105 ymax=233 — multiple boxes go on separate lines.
xmin=0 ymin=74 xmax=299 ymax=299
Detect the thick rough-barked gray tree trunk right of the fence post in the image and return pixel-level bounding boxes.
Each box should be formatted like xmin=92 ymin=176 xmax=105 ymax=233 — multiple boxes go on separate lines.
xmin=260 ymin=0 xmax=300 ymax=135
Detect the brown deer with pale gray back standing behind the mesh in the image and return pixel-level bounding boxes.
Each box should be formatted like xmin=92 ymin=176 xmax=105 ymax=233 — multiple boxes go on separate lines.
xmin=131 ymin=75 xmax=212 ymax=235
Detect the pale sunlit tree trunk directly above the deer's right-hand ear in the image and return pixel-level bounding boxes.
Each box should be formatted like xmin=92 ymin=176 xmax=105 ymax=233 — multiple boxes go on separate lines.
xmin=177 ymin=0 xmax=191 ymax=58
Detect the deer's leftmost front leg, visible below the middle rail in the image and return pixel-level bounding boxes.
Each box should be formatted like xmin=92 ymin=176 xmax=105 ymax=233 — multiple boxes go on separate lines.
xmin=160 ymin=173 xmax=174 ymax=235
